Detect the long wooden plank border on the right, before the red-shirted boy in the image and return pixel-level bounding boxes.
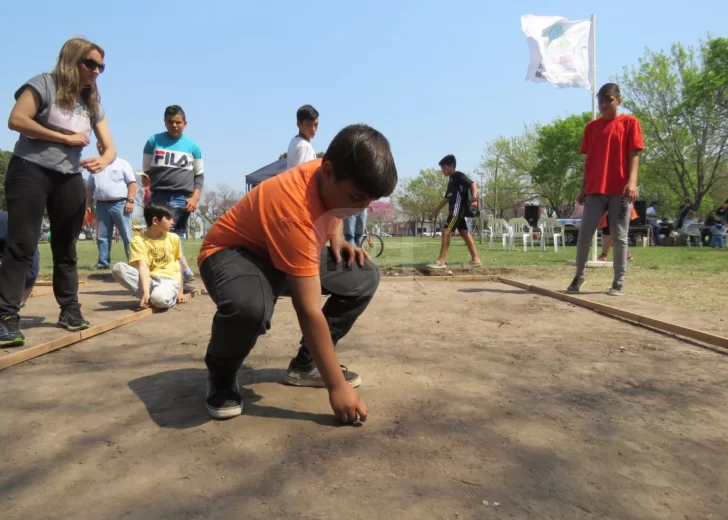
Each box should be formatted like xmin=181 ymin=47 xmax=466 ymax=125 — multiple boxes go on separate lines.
xmin=500 ymin=278 xmax=728 ymax=350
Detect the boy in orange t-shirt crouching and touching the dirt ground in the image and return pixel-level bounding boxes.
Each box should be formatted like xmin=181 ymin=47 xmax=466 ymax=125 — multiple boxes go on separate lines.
xmin=197 ymin=125 xmax=397 ymax=423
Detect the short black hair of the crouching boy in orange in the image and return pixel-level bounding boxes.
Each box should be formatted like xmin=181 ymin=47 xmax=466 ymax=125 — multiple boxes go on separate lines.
xmin=323 ymin=124 xmax=397 ymax=199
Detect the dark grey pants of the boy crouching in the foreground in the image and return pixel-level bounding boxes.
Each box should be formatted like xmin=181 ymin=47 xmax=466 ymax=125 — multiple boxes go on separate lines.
xmin=200 ymin=248 xmax=379 ymax=376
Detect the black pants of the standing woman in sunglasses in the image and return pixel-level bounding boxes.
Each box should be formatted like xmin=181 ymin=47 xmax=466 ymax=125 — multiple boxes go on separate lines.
xmin=0 ymin=156 xmax=86 ymax=314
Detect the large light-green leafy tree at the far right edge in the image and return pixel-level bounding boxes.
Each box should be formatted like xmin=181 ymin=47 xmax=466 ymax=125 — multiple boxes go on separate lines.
xmin=617 ymin=38 xmax=728 ymax=212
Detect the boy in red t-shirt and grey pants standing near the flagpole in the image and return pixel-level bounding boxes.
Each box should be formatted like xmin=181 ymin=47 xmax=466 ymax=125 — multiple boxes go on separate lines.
xmin=566 ymin=83 xmax=645 ymax=296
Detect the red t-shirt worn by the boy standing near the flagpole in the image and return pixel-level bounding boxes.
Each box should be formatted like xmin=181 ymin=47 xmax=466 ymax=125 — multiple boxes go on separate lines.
xmin=581 ymin=115 xmax=645 ymax=195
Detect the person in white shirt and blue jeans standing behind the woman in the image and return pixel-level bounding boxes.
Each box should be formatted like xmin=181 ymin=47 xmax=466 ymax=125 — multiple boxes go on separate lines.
xmin=86 ymin=142 xmax=136 ymax=269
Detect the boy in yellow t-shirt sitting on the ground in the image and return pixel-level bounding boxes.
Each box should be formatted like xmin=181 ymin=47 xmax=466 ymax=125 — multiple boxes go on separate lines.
xmin=111 ymin=202 xmax=190 ymax=309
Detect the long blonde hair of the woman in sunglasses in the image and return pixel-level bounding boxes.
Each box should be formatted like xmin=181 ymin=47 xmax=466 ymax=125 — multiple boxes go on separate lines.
xmin=51 ymin=38 xmax=104 ymax=118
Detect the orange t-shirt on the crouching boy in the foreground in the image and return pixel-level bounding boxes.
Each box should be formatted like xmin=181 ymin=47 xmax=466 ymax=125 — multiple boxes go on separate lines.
xmin=197 ymin=159 xmax=338 ymax=276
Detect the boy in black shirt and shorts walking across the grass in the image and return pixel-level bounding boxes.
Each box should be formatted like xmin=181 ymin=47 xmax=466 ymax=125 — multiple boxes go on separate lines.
xmin=427 ymin=155 xmax=481 ymax=269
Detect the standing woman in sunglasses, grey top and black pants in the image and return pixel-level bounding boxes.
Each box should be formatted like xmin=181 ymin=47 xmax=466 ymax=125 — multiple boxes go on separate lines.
xmin=0 ymin=38 xmax=116 ymax=347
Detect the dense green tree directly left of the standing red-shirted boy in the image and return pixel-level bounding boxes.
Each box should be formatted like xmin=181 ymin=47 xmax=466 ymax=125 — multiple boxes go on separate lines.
xmin=529 ymin=113 xmax=591 ymax=217
